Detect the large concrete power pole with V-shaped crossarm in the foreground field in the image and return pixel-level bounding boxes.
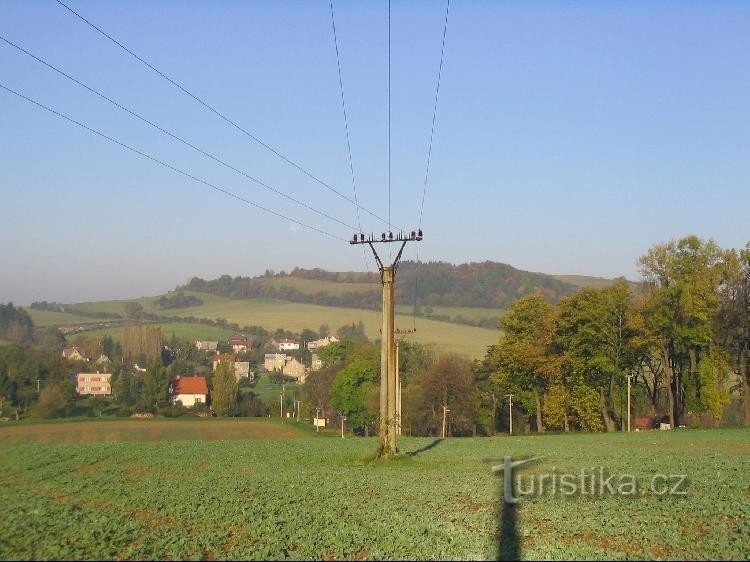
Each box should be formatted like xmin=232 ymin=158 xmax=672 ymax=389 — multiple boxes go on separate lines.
xmin=349 ymin=229 xmax=422 ymax=458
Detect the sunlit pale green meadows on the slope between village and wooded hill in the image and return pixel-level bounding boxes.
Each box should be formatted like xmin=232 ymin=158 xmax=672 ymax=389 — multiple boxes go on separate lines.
xmin=54 ymin=293 xmax=499 ymax=358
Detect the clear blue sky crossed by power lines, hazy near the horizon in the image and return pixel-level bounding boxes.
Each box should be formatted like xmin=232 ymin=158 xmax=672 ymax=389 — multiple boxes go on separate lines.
xmin=0 ymin=0 xmax=750 ymax=304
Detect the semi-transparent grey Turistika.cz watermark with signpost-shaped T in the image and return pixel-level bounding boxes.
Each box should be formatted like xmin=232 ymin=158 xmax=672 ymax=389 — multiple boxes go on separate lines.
xmin=492 ymin=457 xmax=688 ymax=504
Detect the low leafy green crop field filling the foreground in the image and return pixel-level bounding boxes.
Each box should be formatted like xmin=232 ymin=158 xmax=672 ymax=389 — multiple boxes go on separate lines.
xmin=0 ymin=420 xmax=750 ymax=560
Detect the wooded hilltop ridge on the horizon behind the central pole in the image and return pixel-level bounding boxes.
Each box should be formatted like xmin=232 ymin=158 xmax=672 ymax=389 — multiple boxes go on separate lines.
xmin=181 ymin=261 xmax=577 ymax=309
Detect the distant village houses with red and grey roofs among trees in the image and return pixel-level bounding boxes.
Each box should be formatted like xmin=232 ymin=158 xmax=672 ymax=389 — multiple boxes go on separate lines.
xmin=62 ymin=335 xmax=340 ymax=408
